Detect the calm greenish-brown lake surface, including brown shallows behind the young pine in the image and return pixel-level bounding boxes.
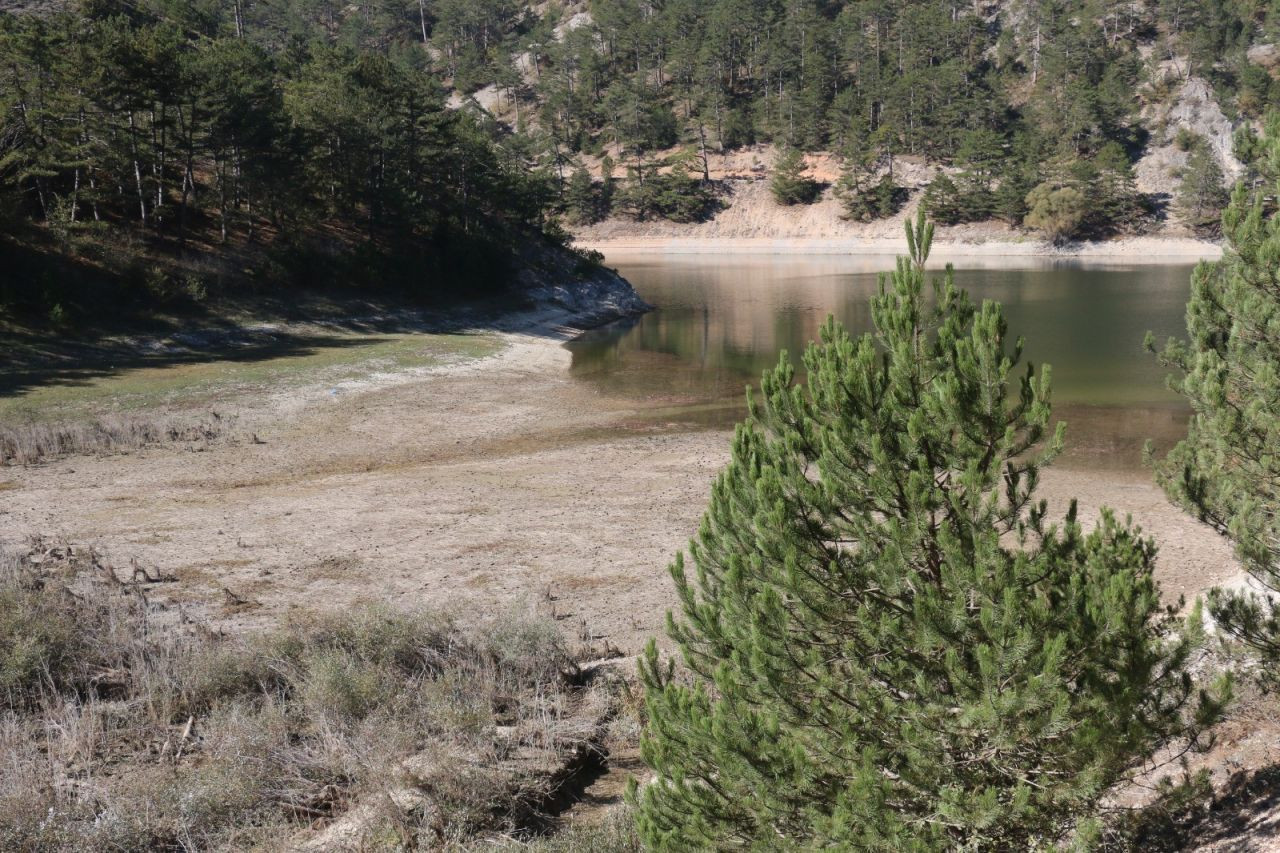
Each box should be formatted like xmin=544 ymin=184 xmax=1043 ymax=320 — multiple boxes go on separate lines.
xmin=570 ymin=255 xmax=1192 ymax=469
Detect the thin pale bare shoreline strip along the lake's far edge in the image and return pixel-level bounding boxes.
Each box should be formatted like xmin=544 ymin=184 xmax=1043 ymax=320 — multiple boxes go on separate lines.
xmin=575 ymin=237 xmax=1222 ymax=264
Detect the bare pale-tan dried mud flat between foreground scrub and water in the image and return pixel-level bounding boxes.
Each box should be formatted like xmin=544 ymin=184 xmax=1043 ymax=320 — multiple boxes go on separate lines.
xmin=0 ymin=308 xmax=1238 ymax=652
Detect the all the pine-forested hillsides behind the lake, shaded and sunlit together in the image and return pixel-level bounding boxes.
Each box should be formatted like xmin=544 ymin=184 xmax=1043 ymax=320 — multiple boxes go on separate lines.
xmin=0 ymin=0 xmax=1280 ymax=322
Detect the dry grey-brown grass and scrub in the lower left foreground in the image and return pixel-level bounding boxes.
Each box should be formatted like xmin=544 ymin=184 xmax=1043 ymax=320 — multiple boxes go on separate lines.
xmin=0 ymin=543 xmax=631 ymax=850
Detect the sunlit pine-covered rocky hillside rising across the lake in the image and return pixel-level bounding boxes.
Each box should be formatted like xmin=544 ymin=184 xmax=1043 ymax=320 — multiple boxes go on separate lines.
xmin=460 ymin=0 xmax=1276 ymax=240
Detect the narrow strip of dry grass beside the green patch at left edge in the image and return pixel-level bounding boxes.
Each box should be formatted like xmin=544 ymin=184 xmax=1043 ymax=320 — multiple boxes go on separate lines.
xmin=0 ymin=412 xmax=232 ymax=465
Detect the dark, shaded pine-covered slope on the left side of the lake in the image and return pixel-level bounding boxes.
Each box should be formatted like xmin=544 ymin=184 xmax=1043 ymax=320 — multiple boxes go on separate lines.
xmin=0 ymin=0 xmax=570 ymax=320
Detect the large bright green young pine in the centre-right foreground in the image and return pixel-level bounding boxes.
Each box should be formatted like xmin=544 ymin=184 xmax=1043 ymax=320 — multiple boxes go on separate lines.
xmin=631 ymin=215 xmax=1219 ymax=850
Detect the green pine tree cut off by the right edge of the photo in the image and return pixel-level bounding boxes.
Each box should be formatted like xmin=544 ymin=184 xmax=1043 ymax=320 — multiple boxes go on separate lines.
xmin=1147 ymin=117 xmax=1280 ymax=685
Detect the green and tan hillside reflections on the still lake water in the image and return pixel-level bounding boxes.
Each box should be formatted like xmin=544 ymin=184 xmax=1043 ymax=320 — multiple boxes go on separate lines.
xmin=571 ymin=256 xmax=1188 ymax=405
